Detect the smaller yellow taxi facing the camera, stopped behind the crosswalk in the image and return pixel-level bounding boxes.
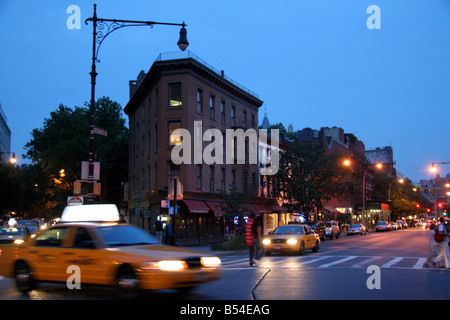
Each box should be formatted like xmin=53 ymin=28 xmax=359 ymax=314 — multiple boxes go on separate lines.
xmin=263 ymin=224 xmax=320 ymax=255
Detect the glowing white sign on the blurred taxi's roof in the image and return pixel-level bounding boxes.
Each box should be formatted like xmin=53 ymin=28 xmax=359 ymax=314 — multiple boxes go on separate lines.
xmin=60 ymin=204 xmax=120 ymax=223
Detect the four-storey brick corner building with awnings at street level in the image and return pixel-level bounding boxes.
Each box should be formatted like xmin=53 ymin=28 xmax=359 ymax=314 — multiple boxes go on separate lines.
xmin=124 ymin=51 xmax=263 ymax=245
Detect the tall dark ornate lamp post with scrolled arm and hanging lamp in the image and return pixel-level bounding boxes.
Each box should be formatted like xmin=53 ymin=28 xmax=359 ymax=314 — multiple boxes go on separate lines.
xmin=85 ymin=4 xmax=189 ymax=203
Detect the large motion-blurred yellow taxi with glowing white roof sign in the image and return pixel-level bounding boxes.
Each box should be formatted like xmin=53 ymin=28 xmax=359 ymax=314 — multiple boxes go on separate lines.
xmin=0 ymin=204 xmax=221 ymax=298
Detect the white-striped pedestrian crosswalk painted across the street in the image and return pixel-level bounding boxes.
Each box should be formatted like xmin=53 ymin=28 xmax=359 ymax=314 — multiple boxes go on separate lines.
xmin=221 ymin=254 xmax=434 ymax=270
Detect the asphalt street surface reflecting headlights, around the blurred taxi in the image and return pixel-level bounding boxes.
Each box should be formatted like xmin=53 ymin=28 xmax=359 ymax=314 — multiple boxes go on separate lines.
xmin=0 ymin=228 xmax=450 ymax=300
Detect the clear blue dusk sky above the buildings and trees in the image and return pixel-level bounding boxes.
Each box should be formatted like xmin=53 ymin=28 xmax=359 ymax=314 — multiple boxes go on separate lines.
xmin=0 ymin=0 xmax=450 ymax=182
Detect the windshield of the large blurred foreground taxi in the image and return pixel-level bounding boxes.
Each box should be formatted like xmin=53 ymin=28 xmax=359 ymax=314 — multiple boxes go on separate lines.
xmin=98 ymin=225 xmax=159 ymax=248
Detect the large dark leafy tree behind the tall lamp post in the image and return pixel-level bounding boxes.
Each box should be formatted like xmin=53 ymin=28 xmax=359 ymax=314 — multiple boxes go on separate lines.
xmin=25 ymin=97 xmax=128 ymax=212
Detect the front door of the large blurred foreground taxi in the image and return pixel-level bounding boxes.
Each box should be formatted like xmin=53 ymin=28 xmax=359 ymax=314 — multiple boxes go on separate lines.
xmin=60 ymin=226 xmax=108 ymax=284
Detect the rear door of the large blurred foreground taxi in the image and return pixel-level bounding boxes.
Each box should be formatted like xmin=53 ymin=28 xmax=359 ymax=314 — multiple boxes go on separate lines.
xmin=24 ymin=226 xmax=69 ymax=281
